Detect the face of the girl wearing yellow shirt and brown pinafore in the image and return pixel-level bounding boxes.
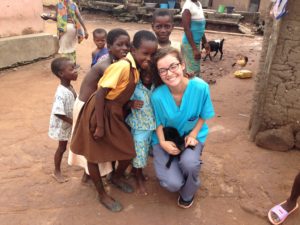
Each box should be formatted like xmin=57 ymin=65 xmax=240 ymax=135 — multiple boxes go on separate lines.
xmin=131 ymin=40 xmax=157 ymax=70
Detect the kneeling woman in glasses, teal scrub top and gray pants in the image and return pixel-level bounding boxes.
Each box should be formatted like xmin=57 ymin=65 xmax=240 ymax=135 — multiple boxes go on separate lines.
xmin=151 ymin=47 xmax=214 ymax=208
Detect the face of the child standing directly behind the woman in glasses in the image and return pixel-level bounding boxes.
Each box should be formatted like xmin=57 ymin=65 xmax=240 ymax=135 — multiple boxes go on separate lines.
xmin=152 ymin=15 xmax=174 ymax=43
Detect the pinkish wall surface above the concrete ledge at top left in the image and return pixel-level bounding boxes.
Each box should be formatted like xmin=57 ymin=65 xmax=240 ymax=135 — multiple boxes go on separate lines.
xmin=0 ymin=0 xmax=44 ymax=37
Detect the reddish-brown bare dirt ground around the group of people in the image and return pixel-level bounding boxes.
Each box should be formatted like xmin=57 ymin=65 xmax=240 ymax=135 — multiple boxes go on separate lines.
xmin=0 ymin=11 xmax=300 ymax=225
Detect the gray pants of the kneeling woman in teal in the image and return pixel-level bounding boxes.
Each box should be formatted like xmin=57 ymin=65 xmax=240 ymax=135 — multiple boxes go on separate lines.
xmin=153 ymin=143 xmax=203 ymax=201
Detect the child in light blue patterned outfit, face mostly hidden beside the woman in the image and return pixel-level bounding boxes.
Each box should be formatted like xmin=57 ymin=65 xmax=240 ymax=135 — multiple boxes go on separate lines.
xmin=126 ymin=70 xmax=156 ymax=195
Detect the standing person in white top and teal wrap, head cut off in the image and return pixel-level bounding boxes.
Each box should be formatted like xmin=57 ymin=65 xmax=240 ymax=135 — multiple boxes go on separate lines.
xmin=181 ymin=0 xmax=209 ymax=77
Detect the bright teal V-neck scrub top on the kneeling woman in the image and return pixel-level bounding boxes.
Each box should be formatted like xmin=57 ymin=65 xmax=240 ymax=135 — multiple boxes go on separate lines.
xmin=151 ymin=77 xmax=215 ymax=145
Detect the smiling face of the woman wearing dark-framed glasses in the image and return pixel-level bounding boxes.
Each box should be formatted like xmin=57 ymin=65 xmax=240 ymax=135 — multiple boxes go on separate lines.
xmin=157 ymin=54 xmax=185 ymax=87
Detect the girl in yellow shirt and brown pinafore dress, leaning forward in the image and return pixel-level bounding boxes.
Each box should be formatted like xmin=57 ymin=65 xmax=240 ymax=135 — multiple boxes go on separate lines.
xmin=71 ymin=30 xmax=157 ymax=212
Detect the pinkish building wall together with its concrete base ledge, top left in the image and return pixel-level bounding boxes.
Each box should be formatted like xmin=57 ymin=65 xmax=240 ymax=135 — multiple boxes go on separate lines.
xmin=0 ymin=0 xmax=57 ymax=69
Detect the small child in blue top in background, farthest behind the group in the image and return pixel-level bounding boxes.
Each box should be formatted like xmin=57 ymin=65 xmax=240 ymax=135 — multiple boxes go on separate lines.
xmin=91 ymin=28 xmax=108 ymax=66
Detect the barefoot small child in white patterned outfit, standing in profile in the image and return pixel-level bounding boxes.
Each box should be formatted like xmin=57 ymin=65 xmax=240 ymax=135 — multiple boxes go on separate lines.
xmin=49 ymin=57 xmax=77 ymax=183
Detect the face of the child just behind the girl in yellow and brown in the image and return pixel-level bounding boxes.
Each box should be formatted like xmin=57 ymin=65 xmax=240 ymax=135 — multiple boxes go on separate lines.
xmin=108 ymin=35 xmax=130 ymax=59
